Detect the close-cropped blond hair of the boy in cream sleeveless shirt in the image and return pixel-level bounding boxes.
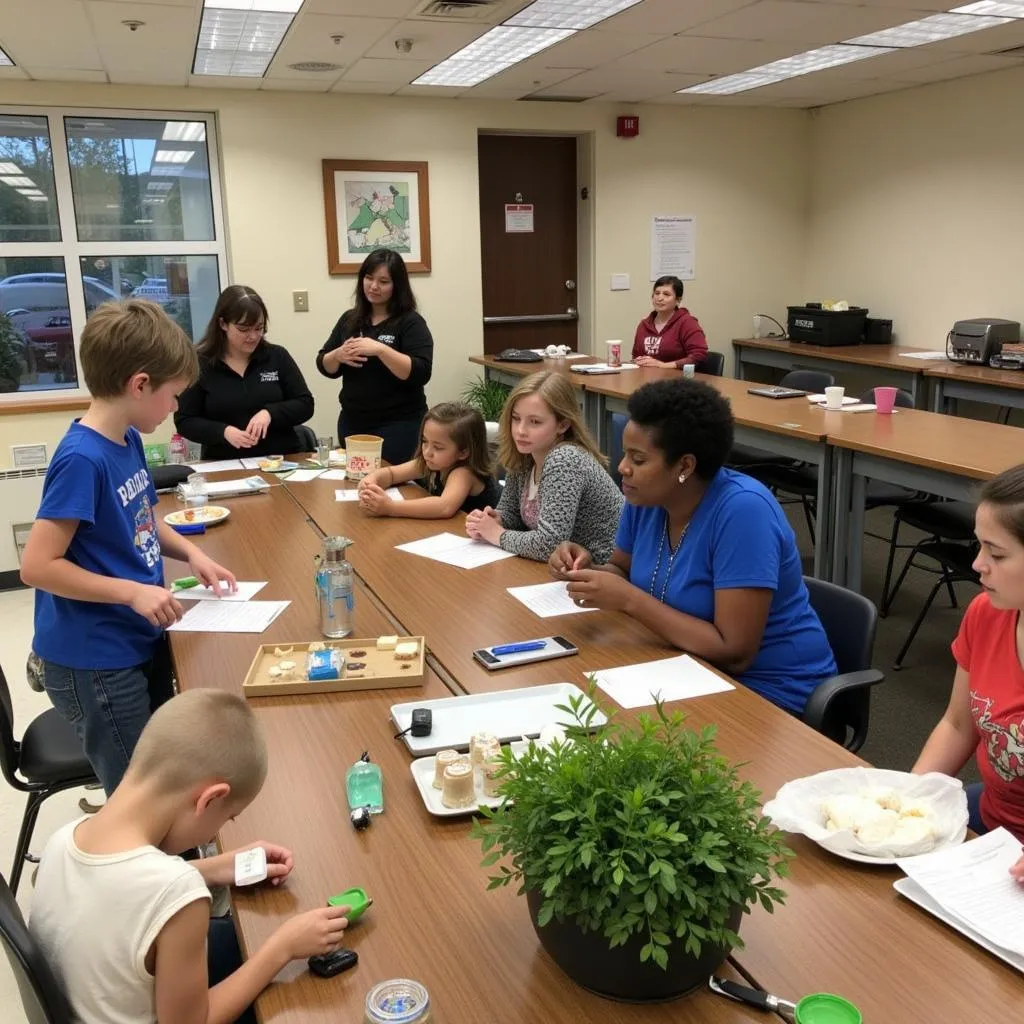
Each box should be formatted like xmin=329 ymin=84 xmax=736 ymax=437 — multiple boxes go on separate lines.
xmin=128 ymin=689 xmax=267 ymax=804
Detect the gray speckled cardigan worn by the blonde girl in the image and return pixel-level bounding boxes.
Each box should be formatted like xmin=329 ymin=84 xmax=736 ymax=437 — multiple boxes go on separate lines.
xmin=498 ymin=441 xmax=623 ymax=565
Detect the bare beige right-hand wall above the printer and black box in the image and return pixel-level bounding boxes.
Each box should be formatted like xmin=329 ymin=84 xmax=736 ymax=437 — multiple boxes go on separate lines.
xmin=802 ymin=69 xmax=1024 ymax=348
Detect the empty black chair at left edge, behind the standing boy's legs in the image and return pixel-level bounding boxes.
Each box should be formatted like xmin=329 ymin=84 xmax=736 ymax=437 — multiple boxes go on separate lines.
xmin=0 ymin=668 xmax=97 ymax=893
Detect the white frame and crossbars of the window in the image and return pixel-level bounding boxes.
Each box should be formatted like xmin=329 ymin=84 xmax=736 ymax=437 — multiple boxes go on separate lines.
xmin=0 ymin=103 xmax=230 ymax=407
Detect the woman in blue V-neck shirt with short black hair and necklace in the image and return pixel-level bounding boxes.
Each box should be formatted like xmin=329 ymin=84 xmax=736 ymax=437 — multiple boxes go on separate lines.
xmin=550 ymin=379 xmax=836 ymax=714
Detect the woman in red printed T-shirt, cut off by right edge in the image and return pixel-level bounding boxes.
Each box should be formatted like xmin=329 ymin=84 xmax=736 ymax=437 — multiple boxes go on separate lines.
xmin=913 ymin=465 xmax=1024 ymax=882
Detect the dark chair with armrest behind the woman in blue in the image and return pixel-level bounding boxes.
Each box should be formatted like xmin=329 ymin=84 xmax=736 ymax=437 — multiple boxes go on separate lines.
xmin=803 ymin=577 xmax=886 ymax=753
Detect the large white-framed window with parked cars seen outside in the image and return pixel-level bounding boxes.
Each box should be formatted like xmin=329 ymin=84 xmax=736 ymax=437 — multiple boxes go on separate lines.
xmin=0 ymin=109 xmax=227 ymax=403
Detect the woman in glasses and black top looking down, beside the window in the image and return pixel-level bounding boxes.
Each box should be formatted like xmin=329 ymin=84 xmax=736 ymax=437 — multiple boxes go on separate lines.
xmin=174 ymin=285 xmax=313 ymax=459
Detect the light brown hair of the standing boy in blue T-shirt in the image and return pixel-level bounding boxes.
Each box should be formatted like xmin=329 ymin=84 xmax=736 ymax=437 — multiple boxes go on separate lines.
xmin=79 ymin=299 xmax=199 ymax=398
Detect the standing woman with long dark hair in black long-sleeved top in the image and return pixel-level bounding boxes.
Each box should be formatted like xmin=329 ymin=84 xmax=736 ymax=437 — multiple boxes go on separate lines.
xmin=316 ymin=249 xmax=434 ymax=465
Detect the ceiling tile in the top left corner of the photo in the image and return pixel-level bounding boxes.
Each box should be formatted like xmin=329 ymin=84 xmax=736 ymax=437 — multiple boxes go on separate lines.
xmin=3 ymin=0 xmax=103 ymax=71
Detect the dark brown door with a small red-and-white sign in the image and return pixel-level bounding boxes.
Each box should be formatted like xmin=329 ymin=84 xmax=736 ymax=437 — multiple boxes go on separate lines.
xmin=477 ymin=135 xmax=578 ymax=353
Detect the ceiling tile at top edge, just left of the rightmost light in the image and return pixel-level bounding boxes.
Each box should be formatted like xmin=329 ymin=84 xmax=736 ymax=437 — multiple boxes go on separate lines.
xmin=688 ymin=0 xmax=912 ymax=50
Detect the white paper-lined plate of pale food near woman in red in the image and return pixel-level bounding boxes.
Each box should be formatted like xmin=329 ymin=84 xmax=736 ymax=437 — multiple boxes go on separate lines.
xmin=764 ymin=768 xmax=968 ymax=864
